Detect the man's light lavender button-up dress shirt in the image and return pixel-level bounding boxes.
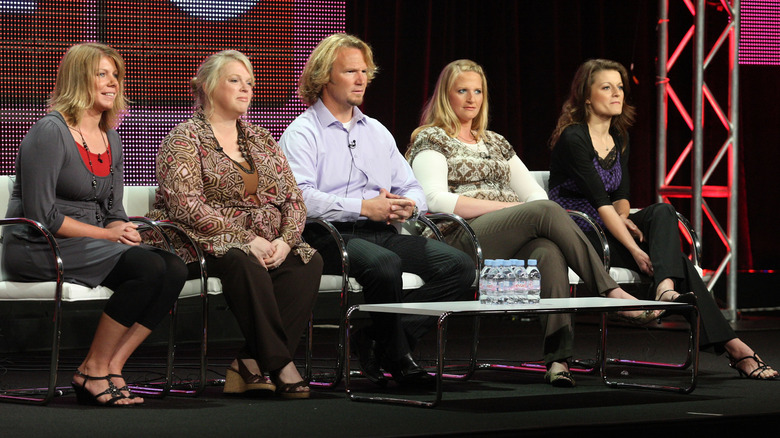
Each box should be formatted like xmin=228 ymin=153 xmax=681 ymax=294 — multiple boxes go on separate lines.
xmin=279 ymin=100 xmax=427 ymax=222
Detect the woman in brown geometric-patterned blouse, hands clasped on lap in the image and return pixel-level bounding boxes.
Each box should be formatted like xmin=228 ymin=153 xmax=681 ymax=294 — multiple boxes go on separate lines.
xmin=150 ymin=50 xmax=322 ymax=398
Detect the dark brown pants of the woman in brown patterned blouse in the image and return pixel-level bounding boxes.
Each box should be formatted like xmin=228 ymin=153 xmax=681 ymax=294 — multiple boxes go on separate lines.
xmin=188 ymin=249 xmax=322 ymax=371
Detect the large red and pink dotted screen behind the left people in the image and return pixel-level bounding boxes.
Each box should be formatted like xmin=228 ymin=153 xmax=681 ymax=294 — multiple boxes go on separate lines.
xmin=0 ymin=0 xmax=345 ymax=185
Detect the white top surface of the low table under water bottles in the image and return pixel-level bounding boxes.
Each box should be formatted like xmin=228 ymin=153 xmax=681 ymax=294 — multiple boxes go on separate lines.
xmin=355 ymin=297 xmax=688 ymax=316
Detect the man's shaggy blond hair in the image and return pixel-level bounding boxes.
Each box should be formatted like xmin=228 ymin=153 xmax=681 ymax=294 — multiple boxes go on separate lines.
xmin=298 ymin=33 xmax=377 ymax=105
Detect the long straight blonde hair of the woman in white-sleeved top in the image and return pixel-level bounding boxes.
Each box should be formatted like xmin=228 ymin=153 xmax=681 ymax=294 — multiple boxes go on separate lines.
xmin=411 ymin=59 xmax=489 ymax=142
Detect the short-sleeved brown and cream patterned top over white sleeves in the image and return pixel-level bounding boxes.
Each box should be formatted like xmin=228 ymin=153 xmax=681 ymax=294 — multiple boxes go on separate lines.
xmin=406 ymin=127 xmax=520 ymax=234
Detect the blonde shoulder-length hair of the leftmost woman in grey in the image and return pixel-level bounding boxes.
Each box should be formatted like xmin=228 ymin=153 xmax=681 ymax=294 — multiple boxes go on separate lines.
xmin=48 ymin=43 xmax=129 ymax=131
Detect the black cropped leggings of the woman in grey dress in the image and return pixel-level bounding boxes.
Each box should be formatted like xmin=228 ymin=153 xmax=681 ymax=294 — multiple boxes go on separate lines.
xmin=101 ymin=247 xmax=187 ymax=330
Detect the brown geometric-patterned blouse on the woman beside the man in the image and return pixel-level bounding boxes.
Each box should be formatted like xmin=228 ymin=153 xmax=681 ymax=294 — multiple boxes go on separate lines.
xmin=149 ymin=111 xmax=314 ymax=262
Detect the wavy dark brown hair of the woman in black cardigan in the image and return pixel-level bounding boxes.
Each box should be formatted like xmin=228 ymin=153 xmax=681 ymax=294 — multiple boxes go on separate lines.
xmin=550 ymin=59 xmax=636 ymax=149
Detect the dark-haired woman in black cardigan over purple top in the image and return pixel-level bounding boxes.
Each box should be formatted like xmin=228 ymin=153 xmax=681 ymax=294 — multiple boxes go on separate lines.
xmin=550 ymin=59 xmax=777 ymax=379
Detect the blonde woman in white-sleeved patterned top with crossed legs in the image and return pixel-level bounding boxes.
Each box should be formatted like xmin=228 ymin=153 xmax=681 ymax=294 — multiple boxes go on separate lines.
xmin=406 ymin=59 xmax=657 ymax=387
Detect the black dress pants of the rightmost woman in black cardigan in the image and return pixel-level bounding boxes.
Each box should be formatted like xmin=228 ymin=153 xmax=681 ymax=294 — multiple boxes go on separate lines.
xmin=587 ymin=203 xmax=737 ymax=354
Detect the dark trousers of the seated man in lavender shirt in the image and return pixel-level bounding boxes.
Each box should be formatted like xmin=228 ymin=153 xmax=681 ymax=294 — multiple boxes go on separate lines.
xmin=304 ymin=221 xmax=476 ymax=360
